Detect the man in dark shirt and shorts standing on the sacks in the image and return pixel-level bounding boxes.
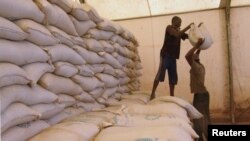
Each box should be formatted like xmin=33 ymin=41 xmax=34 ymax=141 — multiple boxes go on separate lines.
xmin=150 ymin=16 xmax=193 ymax=100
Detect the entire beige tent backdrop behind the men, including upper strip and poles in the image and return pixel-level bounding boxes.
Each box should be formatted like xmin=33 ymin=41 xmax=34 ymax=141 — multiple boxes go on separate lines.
xmin=85 ymin=0 xmax=250 ymax=122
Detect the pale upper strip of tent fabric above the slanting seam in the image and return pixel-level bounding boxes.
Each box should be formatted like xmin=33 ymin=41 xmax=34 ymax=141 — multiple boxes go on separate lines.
xmin=85 ymin=0 xmax=221 ymax=20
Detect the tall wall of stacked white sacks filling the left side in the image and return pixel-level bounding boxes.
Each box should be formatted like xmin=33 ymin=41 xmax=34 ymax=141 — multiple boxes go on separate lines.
xmin=0 ymin=0 xmax=142 ymax=141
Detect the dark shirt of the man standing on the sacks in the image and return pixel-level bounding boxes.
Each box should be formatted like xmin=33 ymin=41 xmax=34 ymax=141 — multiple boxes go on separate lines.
xmin=161 ymin=25 xmax=188 ymax=59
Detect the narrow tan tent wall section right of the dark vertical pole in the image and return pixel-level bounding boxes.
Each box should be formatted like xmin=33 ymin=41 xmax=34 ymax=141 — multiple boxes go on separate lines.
xmin=231 ymin=7 xmax=250 ymax=108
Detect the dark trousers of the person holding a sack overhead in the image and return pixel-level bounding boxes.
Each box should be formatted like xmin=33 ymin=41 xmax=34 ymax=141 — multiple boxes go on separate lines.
xmin=193 ymin=92 xmax=210 ymax=141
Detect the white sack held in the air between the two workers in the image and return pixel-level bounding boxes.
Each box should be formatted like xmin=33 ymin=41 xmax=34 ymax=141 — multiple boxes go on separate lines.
xmin=188 ymin=23 xmax=213 ymax=50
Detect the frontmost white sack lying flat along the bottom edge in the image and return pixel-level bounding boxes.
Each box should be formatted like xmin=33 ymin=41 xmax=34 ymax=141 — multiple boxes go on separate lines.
xmin=95 ymin=125 xmax=194 ymax=141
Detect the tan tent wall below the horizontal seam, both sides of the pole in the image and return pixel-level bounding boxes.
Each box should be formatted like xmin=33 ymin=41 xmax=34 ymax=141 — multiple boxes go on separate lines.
xmin=117 ymin=7 xmax=250 ymax=117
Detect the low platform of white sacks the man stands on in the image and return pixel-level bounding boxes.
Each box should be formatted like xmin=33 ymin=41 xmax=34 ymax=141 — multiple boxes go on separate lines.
xmin=25 ymin=91 xmax=202 ymax=141
